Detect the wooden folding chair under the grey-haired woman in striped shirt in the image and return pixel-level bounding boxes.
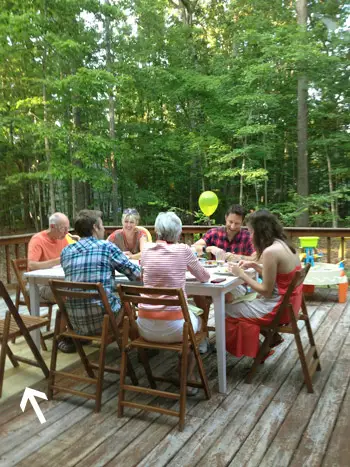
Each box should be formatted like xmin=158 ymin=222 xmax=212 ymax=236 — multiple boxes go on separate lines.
xmin=118 ymin=284 xmax=210 ymax=431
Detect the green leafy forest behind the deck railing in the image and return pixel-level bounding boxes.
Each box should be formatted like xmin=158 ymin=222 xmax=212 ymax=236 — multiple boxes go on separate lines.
xmin=0 ymin=0 xmax=350 ymax=233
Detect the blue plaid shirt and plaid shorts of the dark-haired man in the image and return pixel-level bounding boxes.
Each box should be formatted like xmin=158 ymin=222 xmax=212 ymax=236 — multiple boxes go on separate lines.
xmin=61 ymin=237 xmax=141 ymax=335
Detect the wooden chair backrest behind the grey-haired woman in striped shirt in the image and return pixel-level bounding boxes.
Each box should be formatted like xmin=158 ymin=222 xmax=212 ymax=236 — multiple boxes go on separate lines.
xmin=117 ymin=284 xmax=194 ymax=339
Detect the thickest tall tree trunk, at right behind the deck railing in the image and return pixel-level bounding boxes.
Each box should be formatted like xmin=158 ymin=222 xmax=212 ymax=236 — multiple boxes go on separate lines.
xmin=296 ymin=0 xmax=309 ymax=227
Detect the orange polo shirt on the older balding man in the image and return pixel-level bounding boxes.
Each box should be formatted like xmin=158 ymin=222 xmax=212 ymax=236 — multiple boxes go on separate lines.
xmin=28 ymin=230 xmax=68 ymax=261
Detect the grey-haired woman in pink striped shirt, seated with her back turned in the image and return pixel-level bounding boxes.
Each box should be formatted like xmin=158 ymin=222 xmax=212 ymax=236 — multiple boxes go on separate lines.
xmin=137 ymin=212 xmax=210 ymax=393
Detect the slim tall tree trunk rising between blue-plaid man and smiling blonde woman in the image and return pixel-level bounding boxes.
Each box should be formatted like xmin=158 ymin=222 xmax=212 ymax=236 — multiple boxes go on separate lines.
xmin=105 ymin=0 xmax=118 ymax=224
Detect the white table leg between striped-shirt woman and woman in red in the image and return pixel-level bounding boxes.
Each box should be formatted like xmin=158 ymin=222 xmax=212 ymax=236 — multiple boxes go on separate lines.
xmin=213 ymin=293 xmax=227 ymax=394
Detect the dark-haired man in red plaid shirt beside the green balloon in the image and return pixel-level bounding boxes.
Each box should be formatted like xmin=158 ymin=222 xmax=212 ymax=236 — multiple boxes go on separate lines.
xmin=195 ymin=204 xmax=255 ymax=261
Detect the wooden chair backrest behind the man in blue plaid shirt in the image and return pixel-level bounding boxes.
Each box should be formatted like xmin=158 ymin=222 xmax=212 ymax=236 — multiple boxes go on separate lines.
xmin=49 ymin=280 xmax=118 ymax=335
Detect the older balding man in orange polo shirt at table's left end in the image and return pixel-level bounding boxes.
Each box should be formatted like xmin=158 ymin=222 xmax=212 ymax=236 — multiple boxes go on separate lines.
xmin=28 ymin=212 xmax=69 ymax=303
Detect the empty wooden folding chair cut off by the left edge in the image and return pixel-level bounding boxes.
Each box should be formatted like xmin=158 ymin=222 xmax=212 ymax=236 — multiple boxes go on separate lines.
xmin=0 ymin=281 xmax=49 ymax=397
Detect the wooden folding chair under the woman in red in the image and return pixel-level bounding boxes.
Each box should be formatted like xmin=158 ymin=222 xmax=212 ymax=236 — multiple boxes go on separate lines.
xmin=245 ymin=264 xmax=321 ymax=392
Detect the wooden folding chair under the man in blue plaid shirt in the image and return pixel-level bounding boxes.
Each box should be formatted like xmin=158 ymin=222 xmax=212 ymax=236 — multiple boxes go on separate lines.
xmin=48 ymin=280 xmax=138 ymax=412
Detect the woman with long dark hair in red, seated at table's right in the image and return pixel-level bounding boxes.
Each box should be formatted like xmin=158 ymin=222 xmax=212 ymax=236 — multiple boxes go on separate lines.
xmin=226 ymin=210 xmax=302 ymax=358
